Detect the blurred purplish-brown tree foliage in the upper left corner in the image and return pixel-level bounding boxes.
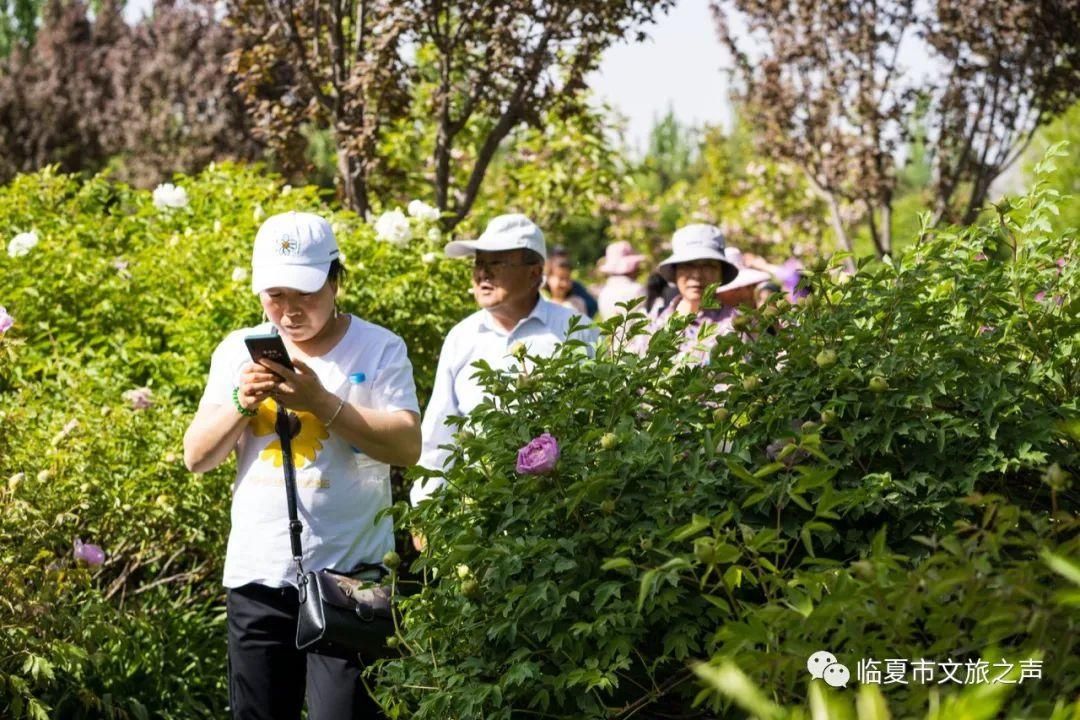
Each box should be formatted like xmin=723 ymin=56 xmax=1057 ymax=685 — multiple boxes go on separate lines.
xmin=0 ymin=0 xmax=264 ymax=187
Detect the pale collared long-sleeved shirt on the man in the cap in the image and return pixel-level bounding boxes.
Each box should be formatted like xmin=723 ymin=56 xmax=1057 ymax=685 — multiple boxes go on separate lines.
xmin=409 ymin=298 xmax=597 ymax=505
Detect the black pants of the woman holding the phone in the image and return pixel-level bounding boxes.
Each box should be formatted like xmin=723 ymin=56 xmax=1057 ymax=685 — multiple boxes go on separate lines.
xmin=226 ymin=584 xmax=383 ymax=720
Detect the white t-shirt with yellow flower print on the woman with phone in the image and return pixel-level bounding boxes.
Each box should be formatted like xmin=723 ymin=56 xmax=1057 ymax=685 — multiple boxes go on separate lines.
xmin=200 ymin=315 xmax=419 ymax=587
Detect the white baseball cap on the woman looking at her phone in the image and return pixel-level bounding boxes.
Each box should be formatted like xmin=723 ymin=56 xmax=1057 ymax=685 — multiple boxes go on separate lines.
xmin=252 ymin=212 xmax=338 ymax=294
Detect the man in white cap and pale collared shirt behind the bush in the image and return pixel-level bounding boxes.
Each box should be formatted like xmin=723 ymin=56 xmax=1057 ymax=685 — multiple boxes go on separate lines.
xmin=409 ymin=214 xmax=596 ymax=505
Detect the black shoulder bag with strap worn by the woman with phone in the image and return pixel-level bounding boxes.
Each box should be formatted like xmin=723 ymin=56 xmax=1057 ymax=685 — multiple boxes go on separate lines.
xmin=274 ymin=405 xmax=394 ymax=660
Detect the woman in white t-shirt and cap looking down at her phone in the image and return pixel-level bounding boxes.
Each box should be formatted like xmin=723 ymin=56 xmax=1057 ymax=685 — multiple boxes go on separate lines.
xmin=184 ymin=213 xmax=420 ymax=720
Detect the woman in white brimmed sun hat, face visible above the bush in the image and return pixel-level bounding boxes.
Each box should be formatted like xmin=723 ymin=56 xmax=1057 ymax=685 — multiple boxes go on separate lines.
xmin=632 ymin=223 xmax=739 ymax=363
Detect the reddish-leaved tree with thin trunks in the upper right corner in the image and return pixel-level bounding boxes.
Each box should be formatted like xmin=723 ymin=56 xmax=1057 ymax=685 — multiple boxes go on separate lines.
xmin=712 ymin=0 xmax=1080 ymax=257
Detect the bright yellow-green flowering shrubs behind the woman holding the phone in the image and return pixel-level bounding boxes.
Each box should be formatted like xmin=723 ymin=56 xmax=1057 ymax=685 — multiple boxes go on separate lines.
xmin=0 ymin=165 xmax=472 ymax=720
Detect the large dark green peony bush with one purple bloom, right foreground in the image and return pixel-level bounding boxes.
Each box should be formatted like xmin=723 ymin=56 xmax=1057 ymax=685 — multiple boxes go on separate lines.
xmin=378 ymin=151 xmax=1080 ymax=719
